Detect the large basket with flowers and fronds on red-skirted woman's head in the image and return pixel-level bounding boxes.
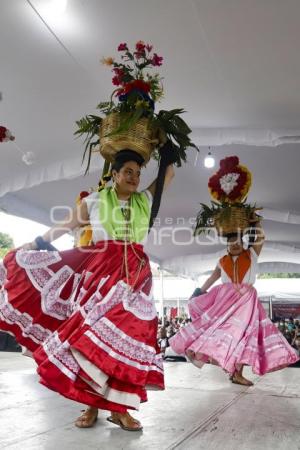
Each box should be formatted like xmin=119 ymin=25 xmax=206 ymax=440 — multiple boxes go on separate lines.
xmin=75 ymin=41 xmax=198 ymax=172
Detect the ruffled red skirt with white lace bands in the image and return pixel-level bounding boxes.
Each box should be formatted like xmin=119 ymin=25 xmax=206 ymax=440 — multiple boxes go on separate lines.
xmin=0 ymin=241 xmax=164 ymax=412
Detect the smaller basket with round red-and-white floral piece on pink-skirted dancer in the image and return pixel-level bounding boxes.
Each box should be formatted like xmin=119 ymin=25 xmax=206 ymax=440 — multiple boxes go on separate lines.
xmin=195 ymin=156 xmax=261 ymax=236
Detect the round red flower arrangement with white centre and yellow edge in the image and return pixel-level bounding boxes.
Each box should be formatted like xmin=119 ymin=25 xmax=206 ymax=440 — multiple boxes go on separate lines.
xmin=208 ymin=156 xmax=252 ymax=203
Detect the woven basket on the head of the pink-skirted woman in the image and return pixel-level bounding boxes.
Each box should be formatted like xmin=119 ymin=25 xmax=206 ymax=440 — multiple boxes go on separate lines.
xmin=214 ymin=206 xmax=250 ymax=236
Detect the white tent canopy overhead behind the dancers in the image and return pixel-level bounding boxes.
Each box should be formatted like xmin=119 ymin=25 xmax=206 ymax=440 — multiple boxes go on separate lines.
xmin=0 ymin=0 xmax=300 ymax=278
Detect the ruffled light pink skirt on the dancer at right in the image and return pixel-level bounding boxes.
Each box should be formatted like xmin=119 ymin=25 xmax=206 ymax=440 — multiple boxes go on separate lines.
xmin=170 ymin=283 xmax=299 ymax=375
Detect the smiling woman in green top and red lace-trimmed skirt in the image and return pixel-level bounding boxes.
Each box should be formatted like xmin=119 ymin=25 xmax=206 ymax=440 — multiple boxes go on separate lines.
xmin=0 ymin=150 xmax=174 ymax=431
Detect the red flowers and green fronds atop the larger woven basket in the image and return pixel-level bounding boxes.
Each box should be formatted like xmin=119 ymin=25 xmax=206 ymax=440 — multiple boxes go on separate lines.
xmin=75 ymin=41 xmax=198 ymax=173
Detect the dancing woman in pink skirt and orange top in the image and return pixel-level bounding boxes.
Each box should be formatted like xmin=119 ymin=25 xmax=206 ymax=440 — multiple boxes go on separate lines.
xmin=170 ymin=225 xmax=299 ymax=386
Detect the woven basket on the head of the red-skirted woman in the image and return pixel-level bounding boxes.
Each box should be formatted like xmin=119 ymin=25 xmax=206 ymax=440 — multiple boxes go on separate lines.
xmin=100 ymin=113 xmax=158 ymax=163
